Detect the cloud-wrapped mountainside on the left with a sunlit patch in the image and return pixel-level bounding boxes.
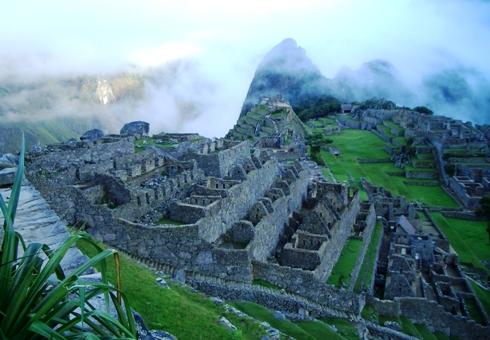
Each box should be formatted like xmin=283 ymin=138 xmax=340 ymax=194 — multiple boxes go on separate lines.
xmin=0 ymin=60 xmax=214 ymax=152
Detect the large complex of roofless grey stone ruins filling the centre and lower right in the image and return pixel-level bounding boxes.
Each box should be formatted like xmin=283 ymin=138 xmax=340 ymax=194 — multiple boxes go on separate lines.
xmin=1 ymin=115 xmax=488 ymax=338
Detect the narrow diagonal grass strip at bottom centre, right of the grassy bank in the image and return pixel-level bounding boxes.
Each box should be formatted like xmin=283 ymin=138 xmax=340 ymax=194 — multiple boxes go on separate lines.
xmin=230 ymin=302 xmax=315 ymax=340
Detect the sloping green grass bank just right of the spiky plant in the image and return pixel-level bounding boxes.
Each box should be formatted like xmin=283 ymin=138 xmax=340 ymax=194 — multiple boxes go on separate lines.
xmin=77 ymin=241 xmax=265 ymax=339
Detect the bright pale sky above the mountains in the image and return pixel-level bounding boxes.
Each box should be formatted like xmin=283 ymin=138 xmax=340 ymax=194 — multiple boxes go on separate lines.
xmin=0 ymin=0 xmax=490 ymax=137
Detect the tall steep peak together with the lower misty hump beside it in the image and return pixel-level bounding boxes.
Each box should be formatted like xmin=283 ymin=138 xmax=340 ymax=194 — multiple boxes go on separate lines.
xmin=240 ymin=39 xmax=415 ymax=116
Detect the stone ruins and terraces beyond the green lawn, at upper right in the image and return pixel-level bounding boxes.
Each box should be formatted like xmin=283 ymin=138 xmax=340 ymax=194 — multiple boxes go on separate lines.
xmin=337 ymin=109 xmax=490 ymax=210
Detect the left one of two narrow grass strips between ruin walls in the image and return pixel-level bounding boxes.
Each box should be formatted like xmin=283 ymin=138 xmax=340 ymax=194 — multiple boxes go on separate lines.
xmin=327 ymin=238 xmax=362 ymax=288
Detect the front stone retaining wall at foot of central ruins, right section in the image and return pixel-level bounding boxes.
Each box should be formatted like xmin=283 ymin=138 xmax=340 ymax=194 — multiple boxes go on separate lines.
xmin=252 ymin=260 xmax=365 ymax=314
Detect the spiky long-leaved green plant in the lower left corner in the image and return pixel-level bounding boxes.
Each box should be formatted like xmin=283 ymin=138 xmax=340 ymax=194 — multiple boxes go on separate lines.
xmin=0 ymin=140 xmax=136 ymax=340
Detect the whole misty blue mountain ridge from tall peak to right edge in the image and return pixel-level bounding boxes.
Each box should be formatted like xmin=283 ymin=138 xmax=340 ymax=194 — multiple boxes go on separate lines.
xmin=241 ymin=39 xmax=490 ymax=124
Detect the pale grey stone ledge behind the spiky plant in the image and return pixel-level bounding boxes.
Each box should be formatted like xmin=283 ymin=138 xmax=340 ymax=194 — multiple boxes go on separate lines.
xmin=0 ymin=175 xmax=88 ymax=273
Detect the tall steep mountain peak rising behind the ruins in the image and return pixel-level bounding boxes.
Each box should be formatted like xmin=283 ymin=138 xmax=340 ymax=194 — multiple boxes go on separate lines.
xmin=240 ymin=38 xmax=331 ymax=117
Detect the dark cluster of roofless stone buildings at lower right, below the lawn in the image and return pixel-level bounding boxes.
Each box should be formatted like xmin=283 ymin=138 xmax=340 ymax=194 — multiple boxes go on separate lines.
xmin=362 ymin=180 xmax=490 ymax=326
